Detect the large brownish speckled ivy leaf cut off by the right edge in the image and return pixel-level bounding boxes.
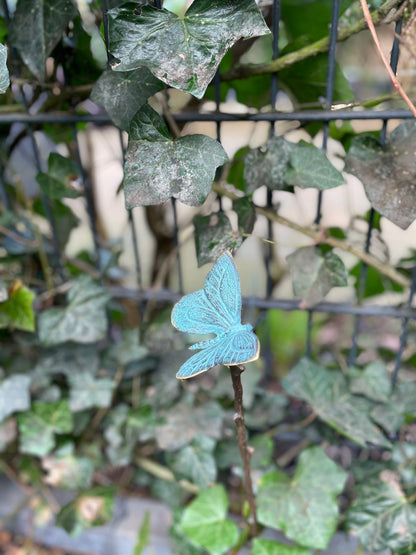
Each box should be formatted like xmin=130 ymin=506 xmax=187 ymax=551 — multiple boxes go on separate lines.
xmin=345 ymin=120 xmax=416 ymax=229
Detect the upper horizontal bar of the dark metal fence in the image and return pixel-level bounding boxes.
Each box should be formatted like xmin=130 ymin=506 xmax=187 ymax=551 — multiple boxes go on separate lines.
xmin=0 ymin=110 xmax=413 ymax=125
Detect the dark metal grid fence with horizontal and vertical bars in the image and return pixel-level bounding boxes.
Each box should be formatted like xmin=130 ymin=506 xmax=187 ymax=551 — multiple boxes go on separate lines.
xmin=0 ymin=0 xmax=416 ymax=381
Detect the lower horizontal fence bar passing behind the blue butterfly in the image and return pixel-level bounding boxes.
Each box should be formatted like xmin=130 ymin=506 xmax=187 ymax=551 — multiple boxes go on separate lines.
xmin=108 ymin=286 xmax=416 ymax=319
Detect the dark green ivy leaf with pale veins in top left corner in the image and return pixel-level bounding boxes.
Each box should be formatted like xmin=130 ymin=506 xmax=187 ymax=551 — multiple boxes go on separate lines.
xmin=10 ymin=0 xmax=77 ymax=82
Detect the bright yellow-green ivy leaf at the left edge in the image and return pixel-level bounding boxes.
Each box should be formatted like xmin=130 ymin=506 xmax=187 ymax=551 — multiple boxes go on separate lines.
xmin=0 ymin=279 xmax=35 ymax=331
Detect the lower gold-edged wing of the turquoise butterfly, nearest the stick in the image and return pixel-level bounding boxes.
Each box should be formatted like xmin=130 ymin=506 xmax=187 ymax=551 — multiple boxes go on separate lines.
xmin=176 ymin=328 xmax=260 ymax=380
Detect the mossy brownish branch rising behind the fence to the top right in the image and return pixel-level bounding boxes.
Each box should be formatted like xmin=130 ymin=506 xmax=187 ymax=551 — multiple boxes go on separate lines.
xmin=221 ymin=0 xmax=403 ymax=81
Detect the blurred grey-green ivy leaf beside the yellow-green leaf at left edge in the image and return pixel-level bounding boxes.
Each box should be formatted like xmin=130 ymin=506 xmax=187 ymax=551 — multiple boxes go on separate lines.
xmin=38 ymin=275 xmax=110 ymax=346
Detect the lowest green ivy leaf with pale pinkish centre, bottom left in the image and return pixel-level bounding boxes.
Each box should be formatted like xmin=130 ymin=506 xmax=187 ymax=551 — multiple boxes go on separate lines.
xmin=56 ymin=486 xmax=116 ymax=536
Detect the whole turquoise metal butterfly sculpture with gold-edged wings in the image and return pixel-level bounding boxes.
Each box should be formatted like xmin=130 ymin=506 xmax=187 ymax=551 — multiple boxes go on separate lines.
xmin=172 ymin=252 xmax=260 ymax=379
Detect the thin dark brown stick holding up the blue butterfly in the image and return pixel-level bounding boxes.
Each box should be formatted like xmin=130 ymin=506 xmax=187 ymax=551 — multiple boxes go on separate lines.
xmin=230 ymin=365 xmax=258 ymax=537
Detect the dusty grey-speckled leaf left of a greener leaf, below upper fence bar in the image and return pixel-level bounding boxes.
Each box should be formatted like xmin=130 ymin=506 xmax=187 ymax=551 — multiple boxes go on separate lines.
xmin=244 ymin=136 xmax=296 ymax=194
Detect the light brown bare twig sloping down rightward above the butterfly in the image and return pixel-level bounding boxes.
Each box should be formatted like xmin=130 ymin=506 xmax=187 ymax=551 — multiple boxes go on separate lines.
xmin=213 ymin=183 xmax=410 ymax=287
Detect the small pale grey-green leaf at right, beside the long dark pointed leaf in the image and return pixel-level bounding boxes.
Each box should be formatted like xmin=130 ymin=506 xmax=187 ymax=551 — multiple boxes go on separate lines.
xmin=350 ymin=361 xmax=391 ymax=403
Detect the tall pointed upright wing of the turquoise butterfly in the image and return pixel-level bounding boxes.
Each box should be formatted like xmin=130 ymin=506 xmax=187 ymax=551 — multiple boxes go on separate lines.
xmin=204 ymin=252 xmax=241 ymax=328
